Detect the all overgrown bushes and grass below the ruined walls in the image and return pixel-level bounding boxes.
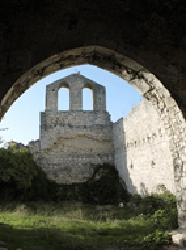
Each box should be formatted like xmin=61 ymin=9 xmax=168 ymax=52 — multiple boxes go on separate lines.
xmin=0 ymin=146 xmax=178 ymax=250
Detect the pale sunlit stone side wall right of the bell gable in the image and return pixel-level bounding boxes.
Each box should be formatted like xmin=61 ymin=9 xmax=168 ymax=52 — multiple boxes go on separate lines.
xmin=113 ymin=99 xmax=176 ymax=196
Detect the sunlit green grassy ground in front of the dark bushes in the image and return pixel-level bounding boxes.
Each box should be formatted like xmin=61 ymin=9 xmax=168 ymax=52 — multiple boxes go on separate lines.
xmin=0 ymin=198 xmax=177 ymax=250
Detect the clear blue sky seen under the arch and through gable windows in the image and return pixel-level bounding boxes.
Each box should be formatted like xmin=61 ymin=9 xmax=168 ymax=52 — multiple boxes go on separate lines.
xmin=0 ymin=65 xmax=142 ymax=147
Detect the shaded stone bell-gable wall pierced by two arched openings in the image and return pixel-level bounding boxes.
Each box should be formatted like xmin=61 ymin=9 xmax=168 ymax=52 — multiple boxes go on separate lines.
xmin=30 ymin=74 xmax=114 ymax=183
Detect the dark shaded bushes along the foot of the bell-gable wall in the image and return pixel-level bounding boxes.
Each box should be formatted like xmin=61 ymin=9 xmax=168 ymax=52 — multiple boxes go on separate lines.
xmin=0 ymin=145 xmax=130 ymax=205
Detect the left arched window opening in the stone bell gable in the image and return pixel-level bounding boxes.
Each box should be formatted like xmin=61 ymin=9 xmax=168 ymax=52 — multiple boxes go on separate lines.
xmin=58 ymin=87 xmax=69 ymax=110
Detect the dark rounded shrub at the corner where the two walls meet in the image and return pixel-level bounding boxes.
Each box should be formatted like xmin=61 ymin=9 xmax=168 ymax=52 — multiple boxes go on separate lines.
xmin=77 ymin=163 xmax=129 ymax=205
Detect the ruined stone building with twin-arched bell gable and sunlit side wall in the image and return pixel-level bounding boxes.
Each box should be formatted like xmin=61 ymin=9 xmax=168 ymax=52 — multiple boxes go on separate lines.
xmin=29 ymin=74 xmax=175 ymax=196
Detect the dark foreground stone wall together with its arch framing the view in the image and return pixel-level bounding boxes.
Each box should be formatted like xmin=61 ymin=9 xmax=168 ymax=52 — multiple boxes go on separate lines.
xmin=0 ymin=0 xmax=186 ymax=245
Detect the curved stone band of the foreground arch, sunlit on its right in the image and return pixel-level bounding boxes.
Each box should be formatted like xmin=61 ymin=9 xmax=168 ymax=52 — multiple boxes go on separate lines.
xmin=0 ymin=46 xmax=186 ymax=233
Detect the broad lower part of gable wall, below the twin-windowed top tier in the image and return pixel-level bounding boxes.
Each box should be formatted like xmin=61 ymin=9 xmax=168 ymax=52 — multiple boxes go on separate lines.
xmin=37 ymin=111 xmax=114 ymax=183
